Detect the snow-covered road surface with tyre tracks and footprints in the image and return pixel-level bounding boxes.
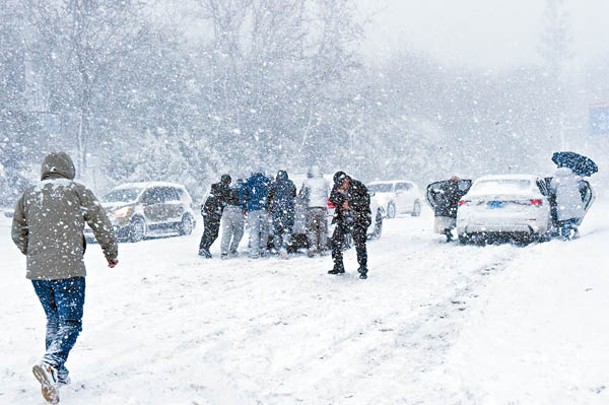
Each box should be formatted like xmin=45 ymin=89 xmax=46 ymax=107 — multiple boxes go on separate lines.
xmin=0 ymin=199 xmax=609 ymax=405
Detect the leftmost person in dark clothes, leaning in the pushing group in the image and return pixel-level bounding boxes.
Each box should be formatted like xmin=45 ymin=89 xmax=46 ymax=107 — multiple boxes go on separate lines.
xmin=199 ymin=174 xmax=232 ymax=259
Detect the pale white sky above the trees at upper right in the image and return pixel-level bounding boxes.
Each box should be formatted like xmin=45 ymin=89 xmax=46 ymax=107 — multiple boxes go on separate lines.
xmin=358 ymin=0 xmax=609 ymax=68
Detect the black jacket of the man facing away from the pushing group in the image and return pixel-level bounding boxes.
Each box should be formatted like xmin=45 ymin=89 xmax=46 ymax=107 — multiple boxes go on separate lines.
xmin=329 ymin=175 xmax=372 ymax=228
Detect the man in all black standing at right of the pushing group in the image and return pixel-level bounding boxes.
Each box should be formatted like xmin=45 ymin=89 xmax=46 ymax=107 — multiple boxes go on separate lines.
xmin=328 ymin=171 xmax=372 ymax=279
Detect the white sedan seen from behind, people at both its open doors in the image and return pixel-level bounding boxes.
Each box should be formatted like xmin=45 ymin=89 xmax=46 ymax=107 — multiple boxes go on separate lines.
xmin=457 ymin=174 xmax=552 ymax=243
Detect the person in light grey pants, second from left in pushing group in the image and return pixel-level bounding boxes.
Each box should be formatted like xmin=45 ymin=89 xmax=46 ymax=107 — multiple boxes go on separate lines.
xmin=220 ymin=179 xmax=247 ymax=259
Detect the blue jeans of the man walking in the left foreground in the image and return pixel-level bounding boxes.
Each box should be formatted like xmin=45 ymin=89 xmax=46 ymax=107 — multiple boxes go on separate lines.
xmin=32 ymin=277 xmax=85 ymax=381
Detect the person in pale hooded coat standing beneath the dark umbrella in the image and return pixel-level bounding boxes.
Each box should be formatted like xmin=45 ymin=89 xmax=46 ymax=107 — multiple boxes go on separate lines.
xmin=550 ymin=167 xmax=585 ymax=240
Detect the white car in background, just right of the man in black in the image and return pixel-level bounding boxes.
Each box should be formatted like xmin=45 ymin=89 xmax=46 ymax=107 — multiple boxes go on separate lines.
xmin=366 ymin=180 xmax=421 ymax=218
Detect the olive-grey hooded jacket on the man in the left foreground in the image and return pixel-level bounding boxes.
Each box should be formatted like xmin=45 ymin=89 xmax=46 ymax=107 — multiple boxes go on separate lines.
xmin=11 ymin=152 xmax=118 ymax=280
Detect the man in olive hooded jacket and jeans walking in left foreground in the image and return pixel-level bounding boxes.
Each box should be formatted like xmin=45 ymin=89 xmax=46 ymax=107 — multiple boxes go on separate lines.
xmin=11 ymin=152 xmax=118 ymax=403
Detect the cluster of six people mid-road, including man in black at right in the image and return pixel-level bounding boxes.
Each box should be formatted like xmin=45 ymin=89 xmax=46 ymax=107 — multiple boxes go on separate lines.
xmin=199 ymin=166 xmax=371 ymax=279
